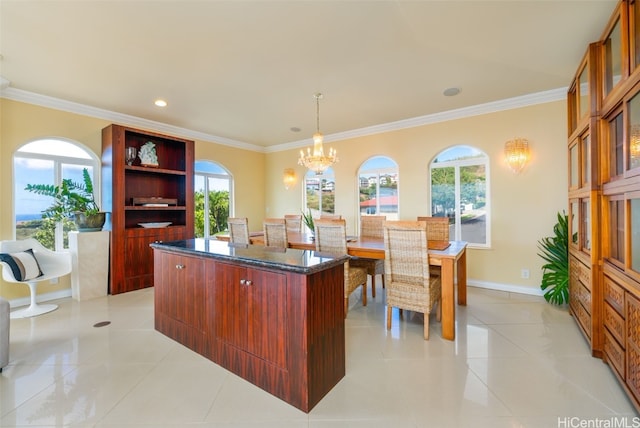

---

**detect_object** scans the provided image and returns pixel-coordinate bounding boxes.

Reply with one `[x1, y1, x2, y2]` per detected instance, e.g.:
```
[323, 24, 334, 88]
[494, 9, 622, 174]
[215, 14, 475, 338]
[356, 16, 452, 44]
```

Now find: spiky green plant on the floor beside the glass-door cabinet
[538, 211, 569, 305]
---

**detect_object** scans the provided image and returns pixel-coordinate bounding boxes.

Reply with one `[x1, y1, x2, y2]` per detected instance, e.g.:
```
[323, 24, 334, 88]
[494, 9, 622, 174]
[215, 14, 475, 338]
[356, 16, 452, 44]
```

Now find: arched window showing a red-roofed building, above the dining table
[358, 156, 398, 220]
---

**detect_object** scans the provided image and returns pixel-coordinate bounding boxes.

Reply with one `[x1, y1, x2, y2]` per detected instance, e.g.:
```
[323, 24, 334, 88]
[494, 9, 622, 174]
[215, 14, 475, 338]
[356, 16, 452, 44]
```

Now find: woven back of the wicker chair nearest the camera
[384, 221, 429, 287]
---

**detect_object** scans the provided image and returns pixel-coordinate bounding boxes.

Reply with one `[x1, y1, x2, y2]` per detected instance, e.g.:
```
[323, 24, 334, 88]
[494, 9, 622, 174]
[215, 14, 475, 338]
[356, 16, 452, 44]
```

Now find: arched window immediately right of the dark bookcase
[194, 161, 233, 238]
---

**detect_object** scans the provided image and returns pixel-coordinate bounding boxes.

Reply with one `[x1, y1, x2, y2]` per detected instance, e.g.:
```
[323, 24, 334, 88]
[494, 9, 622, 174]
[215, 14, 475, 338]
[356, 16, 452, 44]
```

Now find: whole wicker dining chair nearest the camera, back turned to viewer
[384, 221, 442, 340]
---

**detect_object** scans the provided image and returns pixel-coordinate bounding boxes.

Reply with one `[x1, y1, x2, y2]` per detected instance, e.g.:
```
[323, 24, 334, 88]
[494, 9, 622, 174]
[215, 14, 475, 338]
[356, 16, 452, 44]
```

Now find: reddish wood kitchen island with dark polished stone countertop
[151, 239, 347, 412]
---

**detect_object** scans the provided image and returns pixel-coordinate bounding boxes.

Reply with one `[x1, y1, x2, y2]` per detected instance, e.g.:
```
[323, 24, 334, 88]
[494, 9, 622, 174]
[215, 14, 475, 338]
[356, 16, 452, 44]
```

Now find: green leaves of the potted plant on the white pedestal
[25, 168, 100, 221]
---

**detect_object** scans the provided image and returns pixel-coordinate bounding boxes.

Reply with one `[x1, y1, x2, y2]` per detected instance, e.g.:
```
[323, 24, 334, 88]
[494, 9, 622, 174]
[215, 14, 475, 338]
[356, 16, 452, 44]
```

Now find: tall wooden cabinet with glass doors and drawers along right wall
[568, 0, 640, 411]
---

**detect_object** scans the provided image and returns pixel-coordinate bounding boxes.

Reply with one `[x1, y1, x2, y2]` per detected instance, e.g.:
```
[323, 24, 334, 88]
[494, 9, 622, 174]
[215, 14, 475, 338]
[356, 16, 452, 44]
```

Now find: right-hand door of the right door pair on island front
[247, 269, 289, 368]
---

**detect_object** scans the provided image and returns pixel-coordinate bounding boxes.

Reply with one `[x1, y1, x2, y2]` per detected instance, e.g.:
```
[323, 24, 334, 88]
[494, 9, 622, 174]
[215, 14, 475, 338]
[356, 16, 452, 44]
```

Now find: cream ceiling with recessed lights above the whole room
[0, 0, 617, 148]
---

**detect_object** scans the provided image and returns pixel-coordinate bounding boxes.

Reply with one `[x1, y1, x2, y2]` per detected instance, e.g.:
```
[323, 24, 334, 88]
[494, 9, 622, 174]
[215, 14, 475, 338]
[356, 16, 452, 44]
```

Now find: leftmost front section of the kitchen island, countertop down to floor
[154, 252, 207, 354]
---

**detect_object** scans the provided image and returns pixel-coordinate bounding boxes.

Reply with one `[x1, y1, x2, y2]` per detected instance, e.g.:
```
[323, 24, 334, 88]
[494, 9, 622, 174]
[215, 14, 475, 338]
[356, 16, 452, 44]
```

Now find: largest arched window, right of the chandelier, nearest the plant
[429, 146, 490, 247]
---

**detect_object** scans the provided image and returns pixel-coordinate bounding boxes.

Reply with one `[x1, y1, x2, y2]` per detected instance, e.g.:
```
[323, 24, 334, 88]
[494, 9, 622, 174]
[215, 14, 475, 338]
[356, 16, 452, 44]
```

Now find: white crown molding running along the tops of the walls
[0, 87, 567, 153]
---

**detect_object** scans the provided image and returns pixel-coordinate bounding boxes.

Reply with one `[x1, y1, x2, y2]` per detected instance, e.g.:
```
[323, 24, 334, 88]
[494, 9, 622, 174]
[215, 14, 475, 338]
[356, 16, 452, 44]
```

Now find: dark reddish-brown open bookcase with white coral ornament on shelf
[102, 125, 194, 294]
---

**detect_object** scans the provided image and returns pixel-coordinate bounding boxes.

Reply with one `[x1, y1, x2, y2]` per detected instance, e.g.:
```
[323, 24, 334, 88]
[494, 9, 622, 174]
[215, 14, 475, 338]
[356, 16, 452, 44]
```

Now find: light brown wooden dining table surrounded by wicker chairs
[216, 232, 467, 340]
